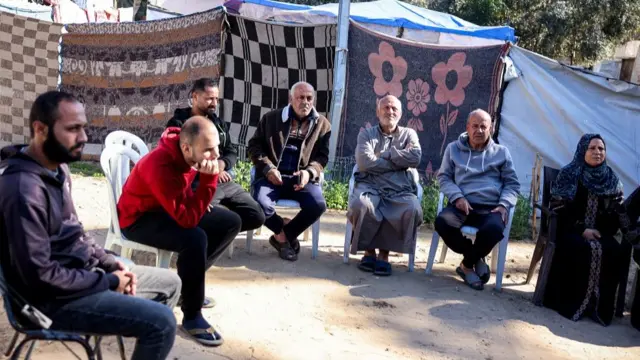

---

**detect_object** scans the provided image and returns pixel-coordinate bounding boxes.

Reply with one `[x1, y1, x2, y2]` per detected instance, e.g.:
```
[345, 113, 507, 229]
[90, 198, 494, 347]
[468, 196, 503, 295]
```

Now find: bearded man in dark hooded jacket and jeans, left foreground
[0, 91, 181, 359]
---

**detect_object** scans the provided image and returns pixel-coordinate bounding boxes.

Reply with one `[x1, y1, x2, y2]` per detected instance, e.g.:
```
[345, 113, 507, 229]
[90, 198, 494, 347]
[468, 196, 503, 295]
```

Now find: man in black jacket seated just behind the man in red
[167, 78, 264, 233]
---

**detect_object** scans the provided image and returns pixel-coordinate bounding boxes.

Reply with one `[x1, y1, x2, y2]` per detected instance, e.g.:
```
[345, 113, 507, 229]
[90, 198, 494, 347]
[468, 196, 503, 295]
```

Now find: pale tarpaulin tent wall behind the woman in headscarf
[498, 46, 640, 195]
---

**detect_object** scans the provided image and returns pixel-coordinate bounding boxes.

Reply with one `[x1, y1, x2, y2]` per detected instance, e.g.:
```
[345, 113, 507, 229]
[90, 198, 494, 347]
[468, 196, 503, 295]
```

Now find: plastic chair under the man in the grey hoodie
[425, 192, 516, 291]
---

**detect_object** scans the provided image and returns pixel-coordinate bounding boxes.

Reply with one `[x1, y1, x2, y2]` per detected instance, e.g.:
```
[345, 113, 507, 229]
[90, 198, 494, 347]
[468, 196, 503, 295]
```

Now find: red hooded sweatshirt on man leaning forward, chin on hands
[118, 127, 218, 228]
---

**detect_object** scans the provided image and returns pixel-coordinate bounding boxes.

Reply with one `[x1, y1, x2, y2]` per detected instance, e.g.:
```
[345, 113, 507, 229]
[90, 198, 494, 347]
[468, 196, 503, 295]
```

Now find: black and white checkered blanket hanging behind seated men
[221, 14, 336, 159]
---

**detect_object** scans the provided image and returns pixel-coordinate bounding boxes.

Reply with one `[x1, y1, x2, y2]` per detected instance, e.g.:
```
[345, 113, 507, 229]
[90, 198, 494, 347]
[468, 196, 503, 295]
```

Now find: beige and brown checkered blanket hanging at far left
[0, 12, 62, 146]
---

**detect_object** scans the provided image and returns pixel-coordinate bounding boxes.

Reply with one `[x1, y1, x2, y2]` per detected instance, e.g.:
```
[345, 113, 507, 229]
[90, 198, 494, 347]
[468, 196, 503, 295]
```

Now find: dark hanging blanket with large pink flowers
[338, 21, 508, 178]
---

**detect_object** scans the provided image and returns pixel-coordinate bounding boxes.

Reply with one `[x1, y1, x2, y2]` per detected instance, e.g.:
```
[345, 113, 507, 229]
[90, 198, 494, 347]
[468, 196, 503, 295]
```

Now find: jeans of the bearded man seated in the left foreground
[44, 259, 181, 360]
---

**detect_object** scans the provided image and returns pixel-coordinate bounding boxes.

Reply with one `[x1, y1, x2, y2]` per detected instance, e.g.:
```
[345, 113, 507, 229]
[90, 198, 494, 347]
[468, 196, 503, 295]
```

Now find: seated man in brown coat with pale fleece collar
[248, 82, 331, 261]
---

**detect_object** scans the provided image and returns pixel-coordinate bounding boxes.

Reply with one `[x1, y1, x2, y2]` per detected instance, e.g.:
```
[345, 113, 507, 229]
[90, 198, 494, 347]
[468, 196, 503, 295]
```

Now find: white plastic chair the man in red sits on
[100, 141, 172, 268]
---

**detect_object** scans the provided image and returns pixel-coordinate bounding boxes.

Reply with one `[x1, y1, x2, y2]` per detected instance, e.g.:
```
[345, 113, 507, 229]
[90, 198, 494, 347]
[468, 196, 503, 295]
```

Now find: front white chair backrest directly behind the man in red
[100, 144, 141, 237]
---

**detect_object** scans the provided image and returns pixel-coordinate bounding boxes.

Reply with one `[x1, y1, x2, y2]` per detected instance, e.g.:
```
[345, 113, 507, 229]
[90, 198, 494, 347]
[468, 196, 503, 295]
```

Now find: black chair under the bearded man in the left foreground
[0, 269, 126, 360]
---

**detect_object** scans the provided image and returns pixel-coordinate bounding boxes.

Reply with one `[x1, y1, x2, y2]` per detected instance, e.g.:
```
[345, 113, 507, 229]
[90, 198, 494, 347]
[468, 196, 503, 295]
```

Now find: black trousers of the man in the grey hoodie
[434, 204, 505, 268]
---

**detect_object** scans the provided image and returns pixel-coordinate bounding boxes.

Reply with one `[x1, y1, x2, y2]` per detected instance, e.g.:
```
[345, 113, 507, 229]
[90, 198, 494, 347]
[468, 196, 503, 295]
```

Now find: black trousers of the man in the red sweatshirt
[122, 210, 241, 320]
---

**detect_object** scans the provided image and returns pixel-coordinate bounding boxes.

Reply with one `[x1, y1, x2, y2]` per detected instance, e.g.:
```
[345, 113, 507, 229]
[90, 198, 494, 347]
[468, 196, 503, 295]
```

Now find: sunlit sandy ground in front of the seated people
[0, 173, 640, 360]
